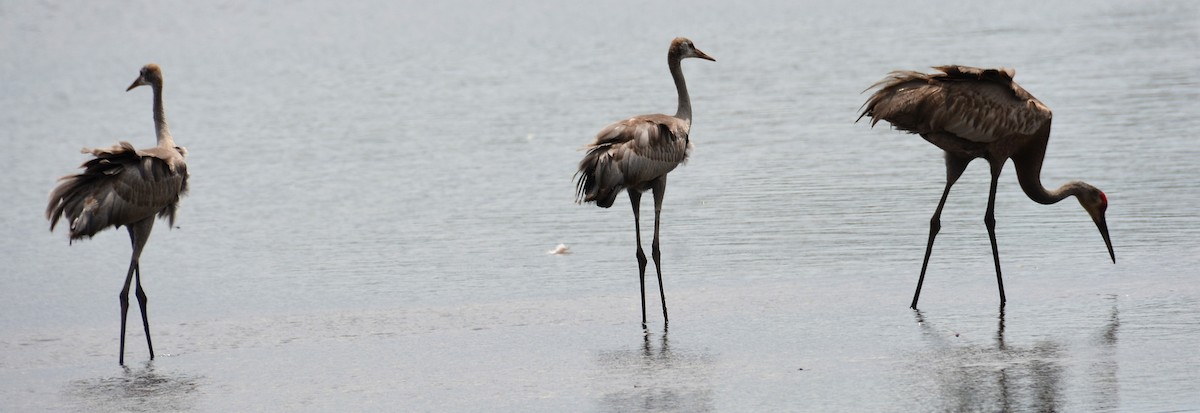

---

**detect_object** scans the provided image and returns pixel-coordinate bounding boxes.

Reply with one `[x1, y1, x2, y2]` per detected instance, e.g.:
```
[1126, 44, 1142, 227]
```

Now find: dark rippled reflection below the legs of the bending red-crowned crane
[914, 309, 1064, 412]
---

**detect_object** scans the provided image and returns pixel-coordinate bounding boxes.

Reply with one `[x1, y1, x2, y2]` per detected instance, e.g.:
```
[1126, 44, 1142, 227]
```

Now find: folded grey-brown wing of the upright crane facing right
[576, 114, 691, 207]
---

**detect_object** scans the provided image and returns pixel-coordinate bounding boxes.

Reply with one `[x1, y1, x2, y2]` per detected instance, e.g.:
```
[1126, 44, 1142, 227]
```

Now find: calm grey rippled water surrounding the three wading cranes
[0, 0, 1200, 412]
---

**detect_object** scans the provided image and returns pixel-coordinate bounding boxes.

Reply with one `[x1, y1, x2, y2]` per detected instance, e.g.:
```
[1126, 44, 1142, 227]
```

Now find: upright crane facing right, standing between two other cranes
[575, 37, 716, 328]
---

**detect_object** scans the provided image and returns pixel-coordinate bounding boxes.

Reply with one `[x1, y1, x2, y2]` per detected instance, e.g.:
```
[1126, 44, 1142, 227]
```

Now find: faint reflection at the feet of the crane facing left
[68, 361, 203, 412]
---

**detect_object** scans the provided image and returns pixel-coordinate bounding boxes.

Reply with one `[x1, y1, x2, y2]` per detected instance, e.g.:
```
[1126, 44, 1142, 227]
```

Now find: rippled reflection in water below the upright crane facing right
[599, 329, 715, 412]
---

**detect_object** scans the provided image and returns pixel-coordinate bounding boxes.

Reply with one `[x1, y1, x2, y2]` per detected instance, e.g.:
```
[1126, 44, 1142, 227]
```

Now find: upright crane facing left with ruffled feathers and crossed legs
[46, 64, 187, 365]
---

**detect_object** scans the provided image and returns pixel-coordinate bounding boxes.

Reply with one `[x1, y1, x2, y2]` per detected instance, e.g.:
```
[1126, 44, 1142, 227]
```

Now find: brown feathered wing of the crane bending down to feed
[859, 66, 1051, 143]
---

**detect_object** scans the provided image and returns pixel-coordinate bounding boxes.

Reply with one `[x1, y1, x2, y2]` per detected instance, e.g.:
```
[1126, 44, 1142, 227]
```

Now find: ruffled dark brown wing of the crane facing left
[46, 142, 187, 240]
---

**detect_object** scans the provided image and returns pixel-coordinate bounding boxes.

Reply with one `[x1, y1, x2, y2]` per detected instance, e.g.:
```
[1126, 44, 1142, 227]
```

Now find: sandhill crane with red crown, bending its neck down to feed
[858, 66, 1117, 309]
